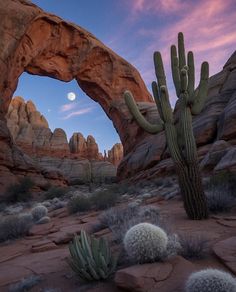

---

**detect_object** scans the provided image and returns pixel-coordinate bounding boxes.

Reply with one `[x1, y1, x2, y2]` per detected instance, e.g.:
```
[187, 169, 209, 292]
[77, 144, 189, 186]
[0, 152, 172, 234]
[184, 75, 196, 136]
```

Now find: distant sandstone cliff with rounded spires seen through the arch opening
[6, 97, 121, 188]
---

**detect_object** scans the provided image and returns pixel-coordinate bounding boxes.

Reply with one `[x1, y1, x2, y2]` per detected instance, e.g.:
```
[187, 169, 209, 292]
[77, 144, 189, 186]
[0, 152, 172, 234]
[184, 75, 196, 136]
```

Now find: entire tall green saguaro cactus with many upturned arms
[124, 32, 209, 220]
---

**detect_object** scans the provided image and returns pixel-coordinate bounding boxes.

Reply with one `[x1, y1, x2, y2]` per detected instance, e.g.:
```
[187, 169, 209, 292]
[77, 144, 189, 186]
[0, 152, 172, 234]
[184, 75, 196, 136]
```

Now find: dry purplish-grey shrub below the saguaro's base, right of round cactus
[179, 234, 208, 259]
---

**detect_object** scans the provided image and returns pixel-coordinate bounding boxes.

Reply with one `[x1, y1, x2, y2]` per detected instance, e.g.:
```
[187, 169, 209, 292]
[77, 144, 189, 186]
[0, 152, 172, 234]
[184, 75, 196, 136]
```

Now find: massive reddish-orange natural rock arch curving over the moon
[0, 0, 152, 153]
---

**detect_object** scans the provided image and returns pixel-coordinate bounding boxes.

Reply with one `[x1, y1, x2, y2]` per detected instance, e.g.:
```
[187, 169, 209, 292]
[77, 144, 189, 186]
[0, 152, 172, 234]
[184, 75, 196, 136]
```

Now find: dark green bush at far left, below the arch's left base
[5, 177, 35, 203]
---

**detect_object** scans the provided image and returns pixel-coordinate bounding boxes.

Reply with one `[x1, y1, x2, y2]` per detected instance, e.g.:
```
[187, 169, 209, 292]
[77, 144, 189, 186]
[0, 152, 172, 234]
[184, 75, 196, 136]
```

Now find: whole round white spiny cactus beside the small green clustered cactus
[124, 223, 168, 263]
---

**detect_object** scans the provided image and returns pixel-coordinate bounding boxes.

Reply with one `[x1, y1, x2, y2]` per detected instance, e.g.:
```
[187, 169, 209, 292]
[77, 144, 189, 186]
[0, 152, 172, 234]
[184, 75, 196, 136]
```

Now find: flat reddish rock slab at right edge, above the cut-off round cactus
[213, 236, 236, 275]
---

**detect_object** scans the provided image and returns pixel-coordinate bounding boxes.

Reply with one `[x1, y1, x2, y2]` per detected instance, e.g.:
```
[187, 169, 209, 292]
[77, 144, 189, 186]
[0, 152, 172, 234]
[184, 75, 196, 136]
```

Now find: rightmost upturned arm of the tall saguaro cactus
[191, 62, 209, 115]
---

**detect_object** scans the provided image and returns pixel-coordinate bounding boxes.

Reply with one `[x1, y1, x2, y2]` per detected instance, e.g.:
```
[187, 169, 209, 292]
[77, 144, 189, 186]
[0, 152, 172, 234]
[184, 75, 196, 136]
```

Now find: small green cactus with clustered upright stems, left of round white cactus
[67, 230, 117, 281]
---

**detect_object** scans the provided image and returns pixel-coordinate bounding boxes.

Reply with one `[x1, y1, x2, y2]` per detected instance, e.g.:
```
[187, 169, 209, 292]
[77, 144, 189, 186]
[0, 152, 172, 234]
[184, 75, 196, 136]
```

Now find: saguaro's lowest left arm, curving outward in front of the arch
[124, 91, 163, 134]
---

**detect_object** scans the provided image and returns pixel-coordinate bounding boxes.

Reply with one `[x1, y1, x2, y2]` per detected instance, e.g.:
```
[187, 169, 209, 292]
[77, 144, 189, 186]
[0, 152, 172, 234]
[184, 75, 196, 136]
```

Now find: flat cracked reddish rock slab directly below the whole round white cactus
[115, 256, 195, 292]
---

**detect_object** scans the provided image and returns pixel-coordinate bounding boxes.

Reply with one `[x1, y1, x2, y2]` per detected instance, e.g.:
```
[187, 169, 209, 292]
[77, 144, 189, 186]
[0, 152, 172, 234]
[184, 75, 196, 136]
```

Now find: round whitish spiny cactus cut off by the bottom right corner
[186, 269, 236, 292]
